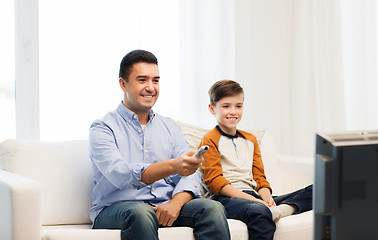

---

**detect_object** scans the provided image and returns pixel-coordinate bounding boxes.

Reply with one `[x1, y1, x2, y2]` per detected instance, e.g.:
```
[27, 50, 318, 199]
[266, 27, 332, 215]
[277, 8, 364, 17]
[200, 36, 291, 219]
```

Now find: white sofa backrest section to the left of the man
[0, 140, 93, 225]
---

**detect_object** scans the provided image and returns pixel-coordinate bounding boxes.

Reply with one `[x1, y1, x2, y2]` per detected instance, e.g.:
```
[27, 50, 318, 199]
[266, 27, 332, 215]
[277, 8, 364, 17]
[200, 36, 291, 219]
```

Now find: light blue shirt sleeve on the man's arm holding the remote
[89, 121, 150, 189]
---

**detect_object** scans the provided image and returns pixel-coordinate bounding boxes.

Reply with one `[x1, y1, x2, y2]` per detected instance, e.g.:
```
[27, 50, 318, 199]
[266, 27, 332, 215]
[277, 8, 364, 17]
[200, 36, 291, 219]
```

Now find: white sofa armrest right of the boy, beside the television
[277, 155, 314, 193]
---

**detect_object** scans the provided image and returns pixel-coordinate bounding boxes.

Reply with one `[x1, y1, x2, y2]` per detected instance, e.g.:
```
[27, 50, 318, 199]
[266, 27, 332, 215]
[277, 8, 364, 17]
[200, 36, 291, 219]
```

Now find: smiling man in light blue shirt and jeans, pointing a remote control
[89, 50, 230, 240]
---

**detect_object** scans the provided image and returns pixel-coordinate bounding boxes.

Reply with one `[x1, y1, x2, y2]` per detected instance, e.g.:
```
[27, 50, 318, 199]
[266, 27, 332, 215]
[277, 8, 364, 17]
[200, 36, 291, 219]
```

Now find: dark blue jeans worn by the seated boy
[213, 185, 312, 240]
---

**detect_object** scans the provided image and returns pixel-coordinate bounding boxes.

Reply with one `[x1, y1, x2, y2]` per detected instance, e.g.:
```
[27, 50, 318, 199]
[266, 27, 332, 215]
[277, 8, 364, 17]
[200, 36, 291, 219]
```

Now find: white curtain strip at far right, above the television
[341, 0, 378, 129]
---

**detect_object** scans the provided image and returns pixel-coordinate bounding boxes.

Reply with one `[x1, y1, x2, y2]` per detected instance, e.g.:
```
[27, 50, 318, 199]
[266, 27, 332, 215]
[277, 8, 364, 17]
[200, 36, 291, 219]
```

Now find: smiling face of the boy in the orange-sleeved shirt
[209, 93, 244, 135]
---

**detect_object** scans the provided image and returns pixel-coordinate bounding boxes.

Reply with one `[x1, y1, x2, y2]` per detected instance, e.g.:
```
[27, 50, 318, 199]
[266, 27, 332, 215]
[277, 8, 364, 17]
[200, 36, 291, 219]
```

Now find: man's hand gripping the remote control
[173, 150, 203, 177]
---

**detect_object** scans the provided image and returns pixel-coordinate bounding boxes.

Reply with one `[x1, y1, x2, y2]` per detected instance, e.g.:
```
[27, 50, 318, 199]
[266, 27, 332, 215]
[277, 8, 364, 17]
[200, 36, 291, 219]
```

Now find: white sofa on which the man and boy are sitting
[0, 123, 313, 240]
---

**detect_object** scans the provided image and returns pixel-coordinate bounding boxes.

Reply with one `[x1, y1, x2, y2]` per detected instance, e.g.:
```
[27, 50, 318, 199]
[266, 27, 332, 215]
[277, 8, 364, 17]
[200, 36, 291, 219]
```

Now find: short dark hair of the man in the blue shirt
[119, 49, 158, 81]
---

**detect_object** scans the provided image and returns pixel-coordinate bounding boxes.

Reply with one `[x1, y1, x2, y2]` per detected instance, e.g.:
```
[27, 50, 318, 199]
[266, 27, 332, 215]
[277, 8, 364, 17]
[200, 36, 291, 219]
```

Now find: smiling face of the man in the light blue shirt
[120, 62, 160, 114]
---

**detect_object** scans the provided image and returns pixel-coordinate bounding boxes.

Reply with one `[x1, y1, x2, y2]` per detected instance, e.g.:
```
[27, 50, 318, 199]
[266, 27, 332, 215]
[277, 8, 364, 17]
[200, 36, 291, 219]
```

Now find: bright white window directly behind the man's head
[39, 0, 179, 141]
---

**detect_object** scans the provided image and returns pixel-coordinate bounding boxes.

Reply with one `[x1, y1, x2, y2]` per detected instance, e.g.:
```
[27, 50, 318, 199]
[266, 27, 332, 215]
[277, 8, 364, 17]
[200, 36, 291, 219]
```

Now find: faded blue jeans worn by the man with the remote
[93, 199, 230, 240]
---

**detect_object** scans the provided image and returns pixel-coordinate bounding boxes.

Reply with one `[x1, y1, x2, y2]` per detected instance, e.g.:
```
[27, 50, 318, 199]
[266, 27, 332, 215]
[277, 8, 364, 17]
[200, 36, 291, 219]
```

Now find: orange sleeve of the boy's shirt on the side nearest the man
[200, 132, 231, 195]
